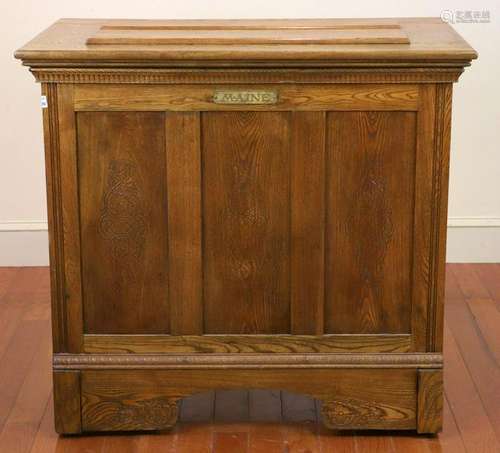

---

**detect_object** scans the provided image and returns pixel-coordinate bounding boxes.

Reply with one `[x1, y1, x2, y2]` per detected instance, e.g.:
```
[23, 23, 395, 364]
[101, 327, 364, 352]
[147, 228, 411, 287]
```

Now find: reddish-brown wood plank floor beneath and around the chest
[0, 264, 500, 453]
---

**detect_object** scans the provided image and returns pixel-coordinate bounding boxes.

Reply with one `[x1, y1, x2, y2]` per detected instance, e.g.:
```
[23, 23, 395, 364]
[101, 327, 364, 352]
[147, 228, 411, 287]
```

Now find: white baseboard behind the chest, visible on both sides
[0, 217, 500, 266]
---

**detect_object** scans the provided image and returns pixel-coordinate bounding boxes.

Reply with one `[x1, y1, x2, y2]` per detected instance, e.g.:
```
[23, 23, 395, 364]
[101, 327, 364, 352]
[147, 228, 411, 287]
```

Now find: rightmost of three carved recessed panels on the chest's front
[325, 112, 416, 334]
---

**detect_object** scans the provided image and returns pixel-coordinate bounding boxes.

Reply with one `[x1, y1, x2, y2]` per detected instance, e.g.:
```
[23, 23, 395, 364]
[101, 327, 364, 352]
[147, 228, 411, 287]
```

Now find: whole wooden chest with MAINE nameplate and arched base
[16, 19, 476, 433]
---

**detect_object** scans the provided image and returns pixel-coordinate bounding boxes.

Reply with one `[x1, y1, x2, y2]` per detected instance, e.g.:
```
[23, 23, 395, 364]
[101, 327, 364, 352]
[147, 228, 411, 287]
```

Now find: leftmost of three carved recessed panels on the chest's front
[77, 112, 169, 333]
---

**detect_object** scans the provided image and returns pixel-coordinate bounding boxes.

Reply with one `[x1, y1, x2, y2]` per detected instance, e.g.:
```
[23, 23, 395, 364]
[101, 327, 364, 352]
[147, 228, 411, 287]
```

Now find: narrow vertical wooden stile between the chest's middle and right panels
[290, 112, 325, 335]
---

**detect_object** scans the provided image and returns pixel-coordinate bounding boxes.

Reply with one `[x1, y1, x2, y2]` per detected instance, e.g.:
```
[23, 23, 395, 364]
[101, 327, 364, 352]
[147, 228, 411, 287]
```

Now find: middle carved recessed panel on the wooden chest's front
[201, 112, 290, 334]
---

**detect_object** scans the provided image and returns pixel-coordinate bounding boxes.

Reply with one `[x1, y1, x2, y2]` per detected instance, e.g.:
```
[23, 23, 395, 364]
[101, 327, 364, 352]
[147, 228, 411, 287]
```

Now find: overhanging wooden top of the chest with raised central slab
[16, 18, 477, 67]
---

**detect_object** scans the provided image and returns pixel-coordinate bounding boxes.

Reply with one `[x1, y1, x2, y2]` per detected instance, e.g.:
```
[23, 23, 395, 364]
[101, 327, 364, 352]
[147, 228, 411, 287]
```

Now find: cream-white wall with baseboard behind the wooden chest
[0, 0, 500, 265]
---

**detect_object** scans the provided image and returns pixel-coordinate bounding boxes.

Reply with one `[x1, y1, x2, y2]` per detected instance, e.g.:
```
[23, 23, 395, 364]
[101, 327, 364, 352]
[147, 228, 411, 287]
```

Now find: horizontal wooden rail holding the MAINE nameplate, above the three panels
[74, 84, 418, 111]
